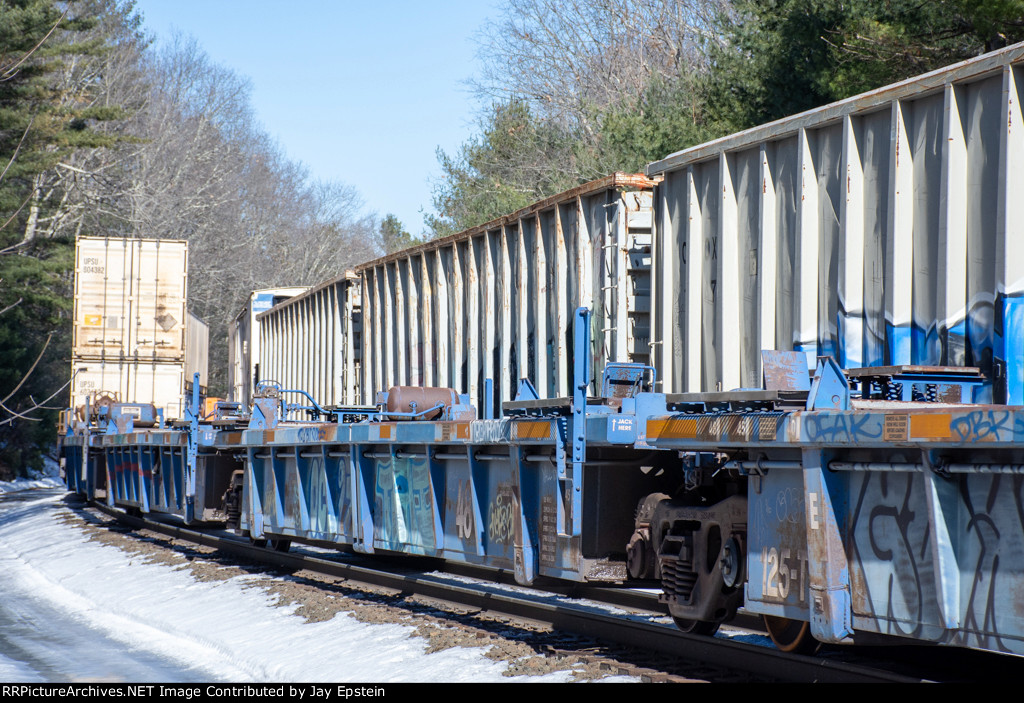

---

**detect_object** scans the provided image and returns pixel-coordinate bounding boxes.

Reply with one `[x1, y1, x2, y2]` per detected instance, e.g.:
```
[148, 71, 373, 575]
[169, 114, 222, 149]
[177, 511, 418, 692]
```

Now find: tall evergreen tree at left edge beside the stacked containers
[0, 0, 120, 478]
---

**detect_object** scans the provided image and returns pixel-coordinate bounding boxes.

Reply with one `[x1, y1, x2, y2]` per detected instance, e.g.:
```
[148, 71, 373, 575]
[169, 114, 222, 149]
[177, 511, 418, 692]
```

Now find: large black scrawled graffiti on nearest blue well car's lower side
[851, 472, 1024, 653]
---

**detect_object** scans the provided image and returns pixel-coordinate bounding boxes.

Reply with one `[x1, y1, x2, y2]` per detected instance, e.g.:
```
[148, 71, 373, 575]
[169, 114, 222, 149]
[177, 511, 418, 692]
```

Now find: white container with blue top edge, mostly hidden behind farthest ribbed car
[227, 285, 309, 404]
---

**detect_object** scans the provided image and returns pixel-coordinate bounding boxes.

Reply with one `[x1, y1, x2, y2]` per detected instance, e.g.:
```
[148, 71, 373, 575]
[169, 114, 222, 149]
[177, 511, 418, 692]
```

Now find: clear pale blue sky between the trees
[136, 0, 498, 234]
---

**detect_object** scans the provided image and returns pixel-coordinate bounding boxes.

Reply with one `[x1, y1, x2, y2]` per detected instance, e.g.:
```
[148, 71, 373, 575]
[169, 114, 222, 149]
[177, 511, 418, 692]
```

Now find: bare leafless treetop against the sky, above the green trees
[473, 0, 728, 132]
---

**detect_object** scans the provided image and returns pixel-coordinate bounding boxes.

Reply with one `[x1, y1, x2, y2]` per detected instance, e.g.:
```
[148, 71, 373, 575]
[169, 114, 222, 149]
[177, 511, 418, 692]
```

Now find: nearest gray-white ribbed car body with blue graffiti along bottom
[646, 45, 1024, 404]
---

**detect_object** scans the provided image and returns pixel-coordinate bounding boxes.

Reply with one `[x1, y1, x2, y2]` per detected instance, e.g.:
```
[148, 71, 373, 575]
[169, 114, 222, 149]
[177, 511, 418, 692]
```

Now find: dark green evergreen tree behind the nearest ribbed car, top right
[707, 0, 1024, 132]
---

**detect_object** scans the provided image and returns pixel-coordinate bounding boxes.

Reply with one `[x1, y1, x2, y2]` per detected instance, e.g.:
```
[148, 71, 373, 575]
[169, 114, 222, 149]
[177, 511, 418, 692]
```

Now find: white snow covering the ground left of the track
[0, 483, 622, 683]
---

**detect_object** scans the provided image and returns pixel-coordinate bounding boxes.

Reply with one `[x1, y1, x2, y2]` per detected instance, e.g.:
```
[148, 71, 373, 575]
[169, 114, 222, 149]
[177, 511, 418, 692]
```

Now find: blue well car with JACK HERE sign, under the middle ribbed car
[240, 310, 679, 583]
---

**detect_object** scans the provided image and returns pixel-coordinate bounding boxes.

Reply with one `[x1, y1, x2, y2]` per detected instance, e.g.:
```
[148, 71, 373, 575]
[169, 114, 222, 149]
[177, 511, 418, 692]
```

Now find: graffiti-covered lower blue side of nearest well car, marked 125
[745, 469, 1024, 654]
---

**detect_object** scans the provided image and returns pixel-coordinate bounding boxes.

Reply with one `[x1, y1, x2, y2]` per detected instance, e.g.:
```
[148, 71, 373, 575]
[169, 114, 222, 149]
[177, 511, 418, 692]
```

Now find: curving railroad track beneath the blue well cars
[66, 495, 928, 683]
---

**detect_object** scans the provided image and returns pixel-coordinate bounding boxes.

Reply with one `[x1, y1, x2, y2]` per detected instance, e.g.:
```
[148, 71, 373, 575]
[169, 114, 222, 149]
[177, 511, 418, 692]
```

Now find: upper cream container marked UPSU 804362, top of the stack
[72, 236, 188, 363]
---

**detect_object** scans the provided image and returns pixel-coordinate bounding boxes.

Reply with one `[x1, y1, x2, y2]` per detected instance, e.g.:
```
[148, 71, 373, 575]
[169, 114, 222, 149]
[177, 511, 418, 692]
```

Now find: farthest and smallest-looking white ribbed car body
[256, 271, 364, 406]
